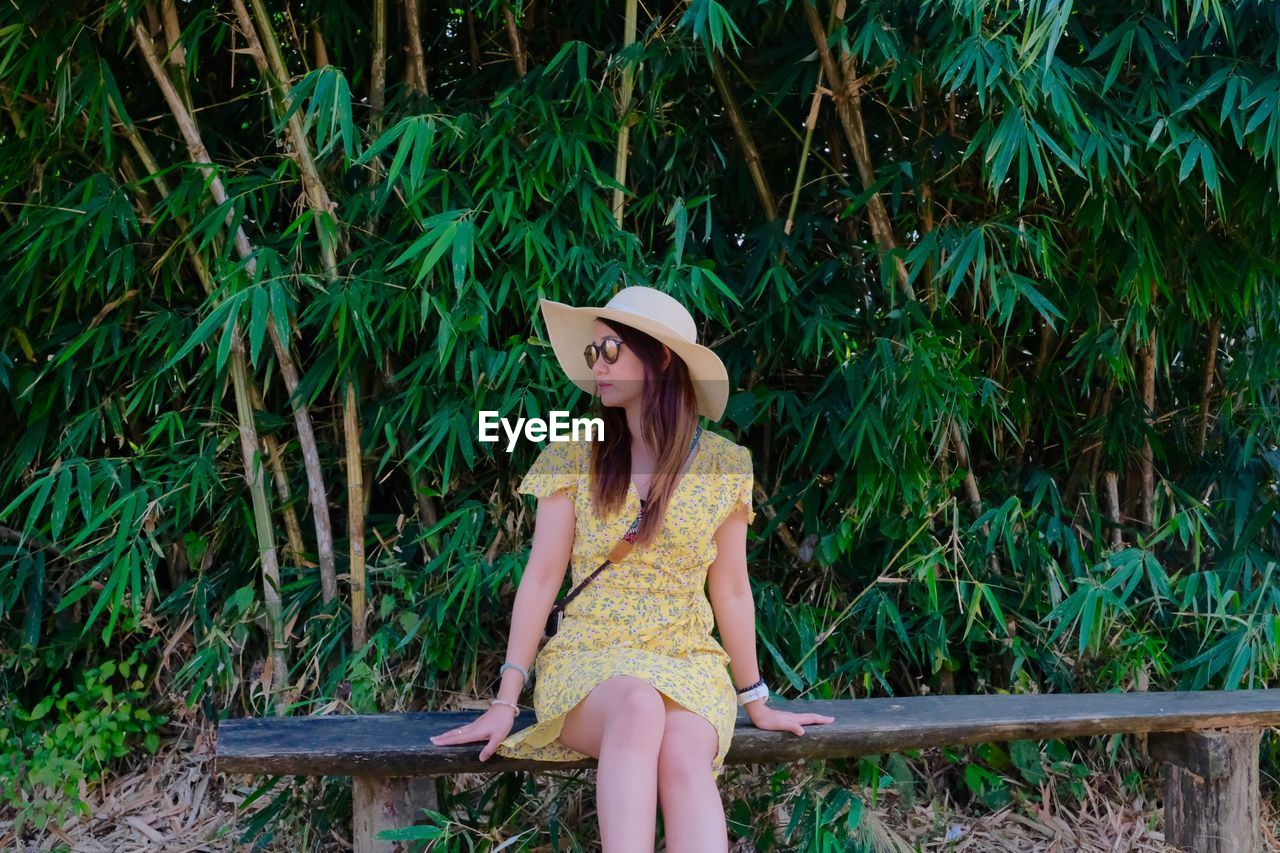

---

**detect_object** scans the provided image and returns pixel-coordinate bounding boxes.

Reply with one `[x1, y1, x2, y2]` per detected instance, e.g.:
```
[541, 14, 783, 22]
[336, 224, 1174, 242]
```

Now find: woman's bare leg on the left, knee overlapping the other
[559, 675, 667, 853]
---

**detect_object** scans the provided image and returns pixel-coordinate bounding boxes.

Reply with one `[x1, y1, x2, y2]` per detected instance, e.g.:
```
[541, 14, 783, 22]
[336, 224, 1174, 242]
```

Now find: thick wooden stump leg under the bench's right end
[1148, 729, 1262, 853]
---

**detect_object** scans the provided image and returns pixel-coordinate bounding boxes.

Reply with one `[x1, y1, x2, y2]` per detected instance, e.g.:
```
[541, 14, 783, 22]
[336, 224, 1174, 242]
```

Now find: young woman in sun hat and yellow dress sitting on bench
[431, 287, 833, 853]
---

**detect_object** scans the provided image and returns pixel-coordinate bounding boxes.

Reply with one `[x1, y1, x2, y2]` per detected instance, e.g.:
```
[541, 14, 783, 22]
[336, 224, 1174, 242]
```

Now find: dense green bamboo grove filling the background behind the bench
[0, 0, 1280, 840]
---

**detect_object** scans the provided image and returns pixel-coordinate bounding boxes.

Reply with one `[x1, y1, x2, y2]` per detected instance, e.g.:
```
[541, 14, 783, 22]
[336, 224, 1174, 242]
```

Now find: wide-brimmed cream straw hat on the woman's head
[538, 284, 728, 420]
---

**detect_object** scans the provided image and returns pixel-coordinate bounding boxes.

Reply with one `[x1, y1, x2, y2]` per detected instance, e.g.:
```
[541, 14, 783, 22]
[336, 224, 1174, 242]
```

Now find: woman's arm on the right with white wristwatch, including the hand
[707, 505, 835, 735]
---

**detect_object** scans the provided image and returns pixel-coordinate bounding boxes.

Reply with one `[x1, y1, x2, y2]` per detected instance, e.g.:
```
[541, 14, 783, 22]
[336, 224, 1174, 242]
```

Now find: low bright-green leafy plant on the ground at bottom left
[0, 647, 168, 833]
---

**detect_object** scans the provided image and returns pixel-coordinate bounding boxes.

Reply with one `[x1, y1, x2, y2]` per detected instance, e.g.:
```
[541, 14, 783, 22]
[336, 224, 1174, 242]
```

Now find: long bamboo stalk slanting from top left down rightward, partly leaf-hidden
[133, 23, 338, 603]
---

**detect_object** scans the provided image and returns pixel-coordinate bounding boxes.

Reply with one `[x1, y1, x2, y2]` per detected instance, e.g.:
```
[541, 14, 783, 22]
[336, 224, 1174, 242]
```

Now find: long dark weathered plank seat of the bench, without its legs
[216, 689, 1280, 776]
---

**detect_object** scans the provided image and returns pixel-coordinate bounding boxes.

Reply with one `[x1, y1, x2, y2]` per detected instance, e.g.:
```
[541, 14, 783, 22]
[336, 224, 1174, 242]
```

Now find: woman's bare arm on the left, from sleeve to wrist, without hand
[495, 489, 575, 701]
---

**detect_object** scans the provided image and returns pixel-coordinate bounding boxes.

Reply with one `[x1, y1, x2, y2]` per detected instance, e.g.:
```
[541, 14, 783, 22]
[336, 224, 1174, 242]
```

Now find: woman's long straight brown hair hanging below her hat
[591, 318, 704, 547]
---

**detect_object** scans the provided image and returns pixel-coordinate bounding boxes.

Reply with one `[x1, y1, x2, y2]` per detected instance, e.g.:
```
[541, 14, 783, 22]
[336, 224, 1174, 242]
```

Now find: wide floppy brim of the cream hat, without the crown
[538, 298, 728, 420]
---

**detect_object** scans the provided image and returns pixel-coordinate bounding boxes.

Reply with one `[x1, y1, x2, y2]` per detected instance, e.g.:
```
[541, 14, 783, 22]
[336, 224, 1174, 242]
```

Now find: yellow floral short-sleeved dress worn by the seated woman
[497, 429, 755, 779]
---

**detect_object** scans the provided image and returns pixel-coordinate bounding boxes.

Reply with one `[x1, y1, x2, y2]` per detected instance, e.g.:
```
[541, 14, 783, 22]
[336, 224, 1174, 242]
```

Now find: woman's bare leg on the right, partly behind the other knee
[658, 694, 728, 853]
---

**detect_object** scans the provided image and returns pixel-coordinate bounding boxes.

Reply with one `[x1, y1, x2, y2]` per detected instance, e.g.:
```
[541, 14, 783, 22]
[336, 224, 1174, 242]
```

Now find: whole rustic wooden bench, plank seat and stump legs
[216, 689, 1280, 853]
